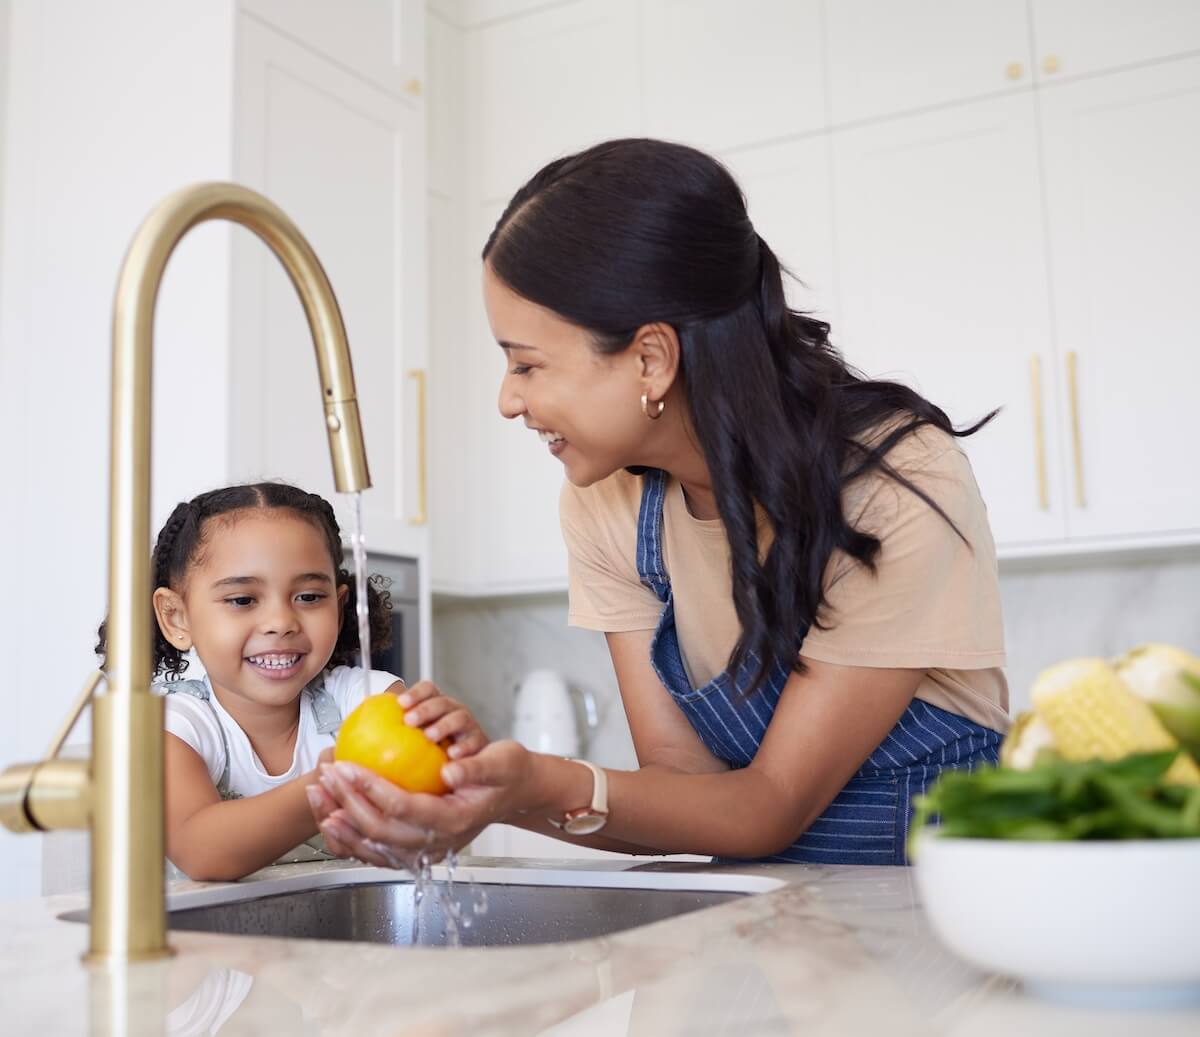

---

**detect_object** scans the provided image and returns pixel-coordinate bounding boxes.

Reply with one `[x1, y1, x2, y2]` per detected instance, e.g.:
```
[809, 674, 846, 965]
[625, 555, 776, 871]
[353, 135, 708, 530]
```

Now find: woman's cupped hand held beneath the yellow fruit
[310, 741, 534, 870]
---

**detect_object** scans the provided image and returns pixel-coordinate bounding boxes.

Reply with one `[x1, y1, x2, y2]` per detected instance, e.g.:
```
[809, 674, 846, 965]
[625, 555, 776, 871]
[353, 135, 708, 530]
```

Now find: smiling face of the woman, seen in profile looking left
[484, 263, 665, 486]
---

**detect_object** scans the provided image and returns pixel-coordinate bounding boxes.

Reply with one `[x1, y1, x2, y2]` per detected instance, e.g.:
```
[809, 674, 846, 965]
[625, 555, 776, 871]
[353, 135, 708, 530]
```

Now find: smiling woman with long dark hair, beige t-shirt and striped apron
[314, 140, 1007, 864]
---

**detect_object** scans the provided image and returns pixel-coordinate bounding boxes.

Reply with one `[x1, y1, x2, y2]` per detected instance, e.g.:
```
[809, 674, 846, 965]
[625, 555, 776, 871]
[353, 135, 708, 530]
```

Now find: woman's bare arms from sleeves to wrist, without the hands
[501, 631, 924, 857]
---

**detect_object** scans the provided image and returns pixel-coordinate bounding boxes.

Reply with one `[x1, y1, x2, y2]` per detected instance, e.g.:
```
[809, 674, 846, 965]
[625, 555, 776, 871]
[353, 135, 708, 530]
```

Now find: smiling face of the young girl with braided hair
[155, 509, 348, 706]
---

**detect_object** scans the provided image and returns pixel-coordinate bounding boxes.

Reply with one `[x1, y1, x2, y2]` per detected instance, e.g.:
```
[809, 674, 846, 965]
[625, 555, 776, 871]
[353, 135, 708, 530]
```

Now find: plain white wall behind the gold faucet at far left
[0, 0, 234, 899]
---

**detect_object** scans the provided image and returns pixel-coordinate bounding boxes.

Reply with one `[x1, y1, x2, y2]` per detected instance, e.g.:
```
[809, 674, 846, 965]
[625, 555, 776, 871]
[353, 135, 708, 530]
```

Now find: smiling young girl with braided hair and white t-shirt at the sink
[96, 482, 478, 880]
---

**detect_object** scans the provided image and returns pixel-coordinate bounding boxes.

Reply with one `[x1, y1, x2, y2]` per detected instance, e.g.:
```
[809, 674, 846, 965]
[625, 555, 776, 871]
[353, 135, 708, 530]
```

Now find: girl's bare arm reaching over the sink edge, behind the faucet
[166, 733, 317, 882]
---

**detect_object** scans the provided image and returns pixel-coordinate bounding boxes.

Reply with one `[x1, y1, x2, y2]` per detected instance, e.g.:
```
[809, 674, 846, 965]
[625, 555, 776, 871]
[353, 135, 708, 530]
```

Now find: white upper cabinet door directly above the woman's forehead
[467, 0, 642, 206]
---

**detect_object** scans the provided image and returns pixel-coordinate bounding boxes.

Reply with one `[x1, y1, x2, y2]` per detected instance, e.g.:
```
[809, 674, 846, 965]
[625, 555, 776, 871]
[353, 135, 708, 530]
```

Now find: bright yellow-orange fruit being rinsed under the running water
[334, 691, 449, 796]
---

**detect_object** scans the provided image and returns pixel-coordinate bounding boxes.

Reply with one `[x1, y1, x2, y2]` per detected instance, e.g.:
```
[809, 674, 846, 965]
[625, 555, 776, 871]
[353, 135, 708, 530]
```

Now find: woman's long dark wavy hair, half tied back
[484, 133, 995, 694]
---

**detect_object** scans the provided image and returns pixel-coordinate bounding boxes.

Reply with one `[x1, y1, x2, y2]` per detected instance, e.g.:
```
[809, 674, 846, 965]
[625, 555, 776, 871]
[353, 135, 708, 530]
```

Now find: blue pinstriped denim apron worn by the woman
[637, 469, 1001, 864]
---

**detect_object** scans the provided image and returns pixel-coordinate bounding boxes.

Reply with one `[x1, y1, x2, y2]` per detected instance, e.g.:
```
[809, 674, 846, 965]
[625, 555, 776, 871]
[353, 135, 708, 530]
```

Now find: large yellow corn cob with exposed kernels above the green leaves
[1032, 659, 1200, 785]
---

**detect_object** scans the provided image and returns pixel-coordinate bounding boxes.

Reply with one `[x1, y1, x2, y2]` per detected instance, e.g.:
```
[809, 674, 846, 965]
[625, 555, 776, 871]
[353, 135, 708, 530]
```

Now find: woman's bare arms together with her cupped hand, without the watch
[314, 631, 924, 858]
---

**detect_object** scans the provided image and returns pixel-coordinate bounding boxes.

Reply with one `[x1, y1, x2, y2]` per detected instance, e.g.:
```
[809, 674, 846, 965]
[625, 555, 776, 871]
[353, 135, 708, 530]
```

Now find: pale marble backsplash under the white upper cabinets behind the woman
[433, 551, 1200, 753]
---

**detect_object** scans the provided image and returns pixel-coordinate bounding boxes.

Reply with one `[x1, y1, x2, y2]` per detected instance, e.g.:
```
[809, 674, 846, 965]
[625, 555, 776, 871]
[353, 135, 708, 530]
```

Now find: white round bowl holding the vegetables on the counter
[916, 831, 1200, 1007]
